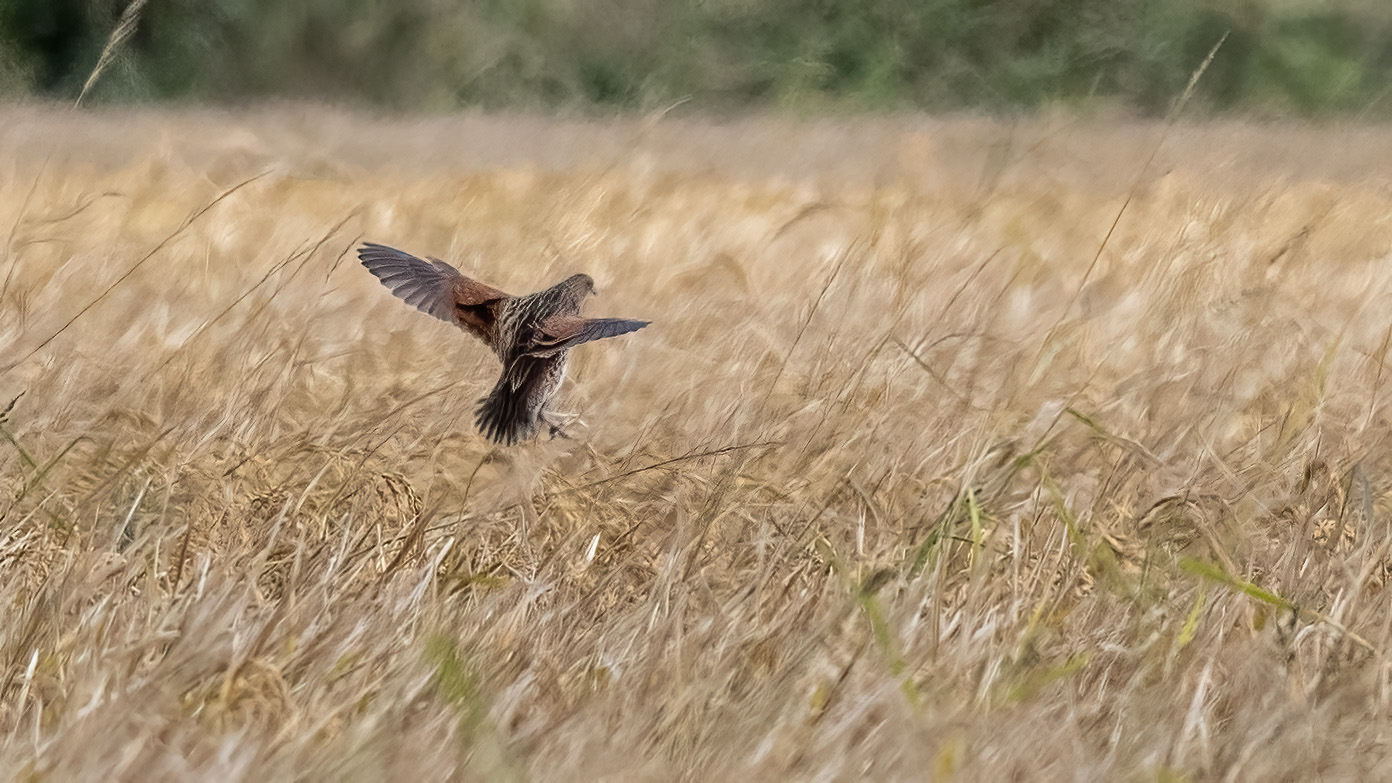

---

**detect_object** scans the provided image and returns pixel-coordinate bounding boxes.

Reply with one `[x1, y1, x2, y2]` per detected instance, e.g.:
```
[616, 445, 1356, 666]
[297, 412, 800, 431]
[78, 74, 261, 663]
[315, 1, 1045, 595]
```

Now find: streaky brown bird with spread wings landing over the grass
[358, 242, 649, 446]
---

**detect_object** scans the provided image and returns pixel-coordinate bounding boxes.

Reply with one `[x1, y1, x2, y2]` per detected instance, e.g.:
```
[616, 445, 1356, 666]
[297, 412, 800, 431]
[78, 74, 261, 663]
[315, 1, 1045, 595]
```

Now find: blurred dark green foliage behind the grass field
[0, 0, 1392, 114]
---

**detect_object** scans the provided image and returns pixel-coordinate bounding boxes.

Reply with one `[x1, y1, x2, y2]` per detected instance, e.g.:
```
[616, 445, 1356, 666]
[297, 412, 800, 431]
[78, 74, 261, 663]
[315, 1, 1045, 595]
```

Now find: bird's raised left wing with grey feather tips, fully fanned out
[358, 242, 511, 346]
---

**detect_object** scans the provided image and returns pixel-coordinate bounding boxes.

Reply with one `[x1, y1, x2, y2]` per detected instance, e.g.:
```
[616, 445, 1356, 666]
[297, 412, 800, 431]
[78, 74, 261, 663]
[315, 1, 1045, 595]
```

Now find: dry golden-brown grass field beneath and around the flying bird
[0, 106, 1392, 783]
